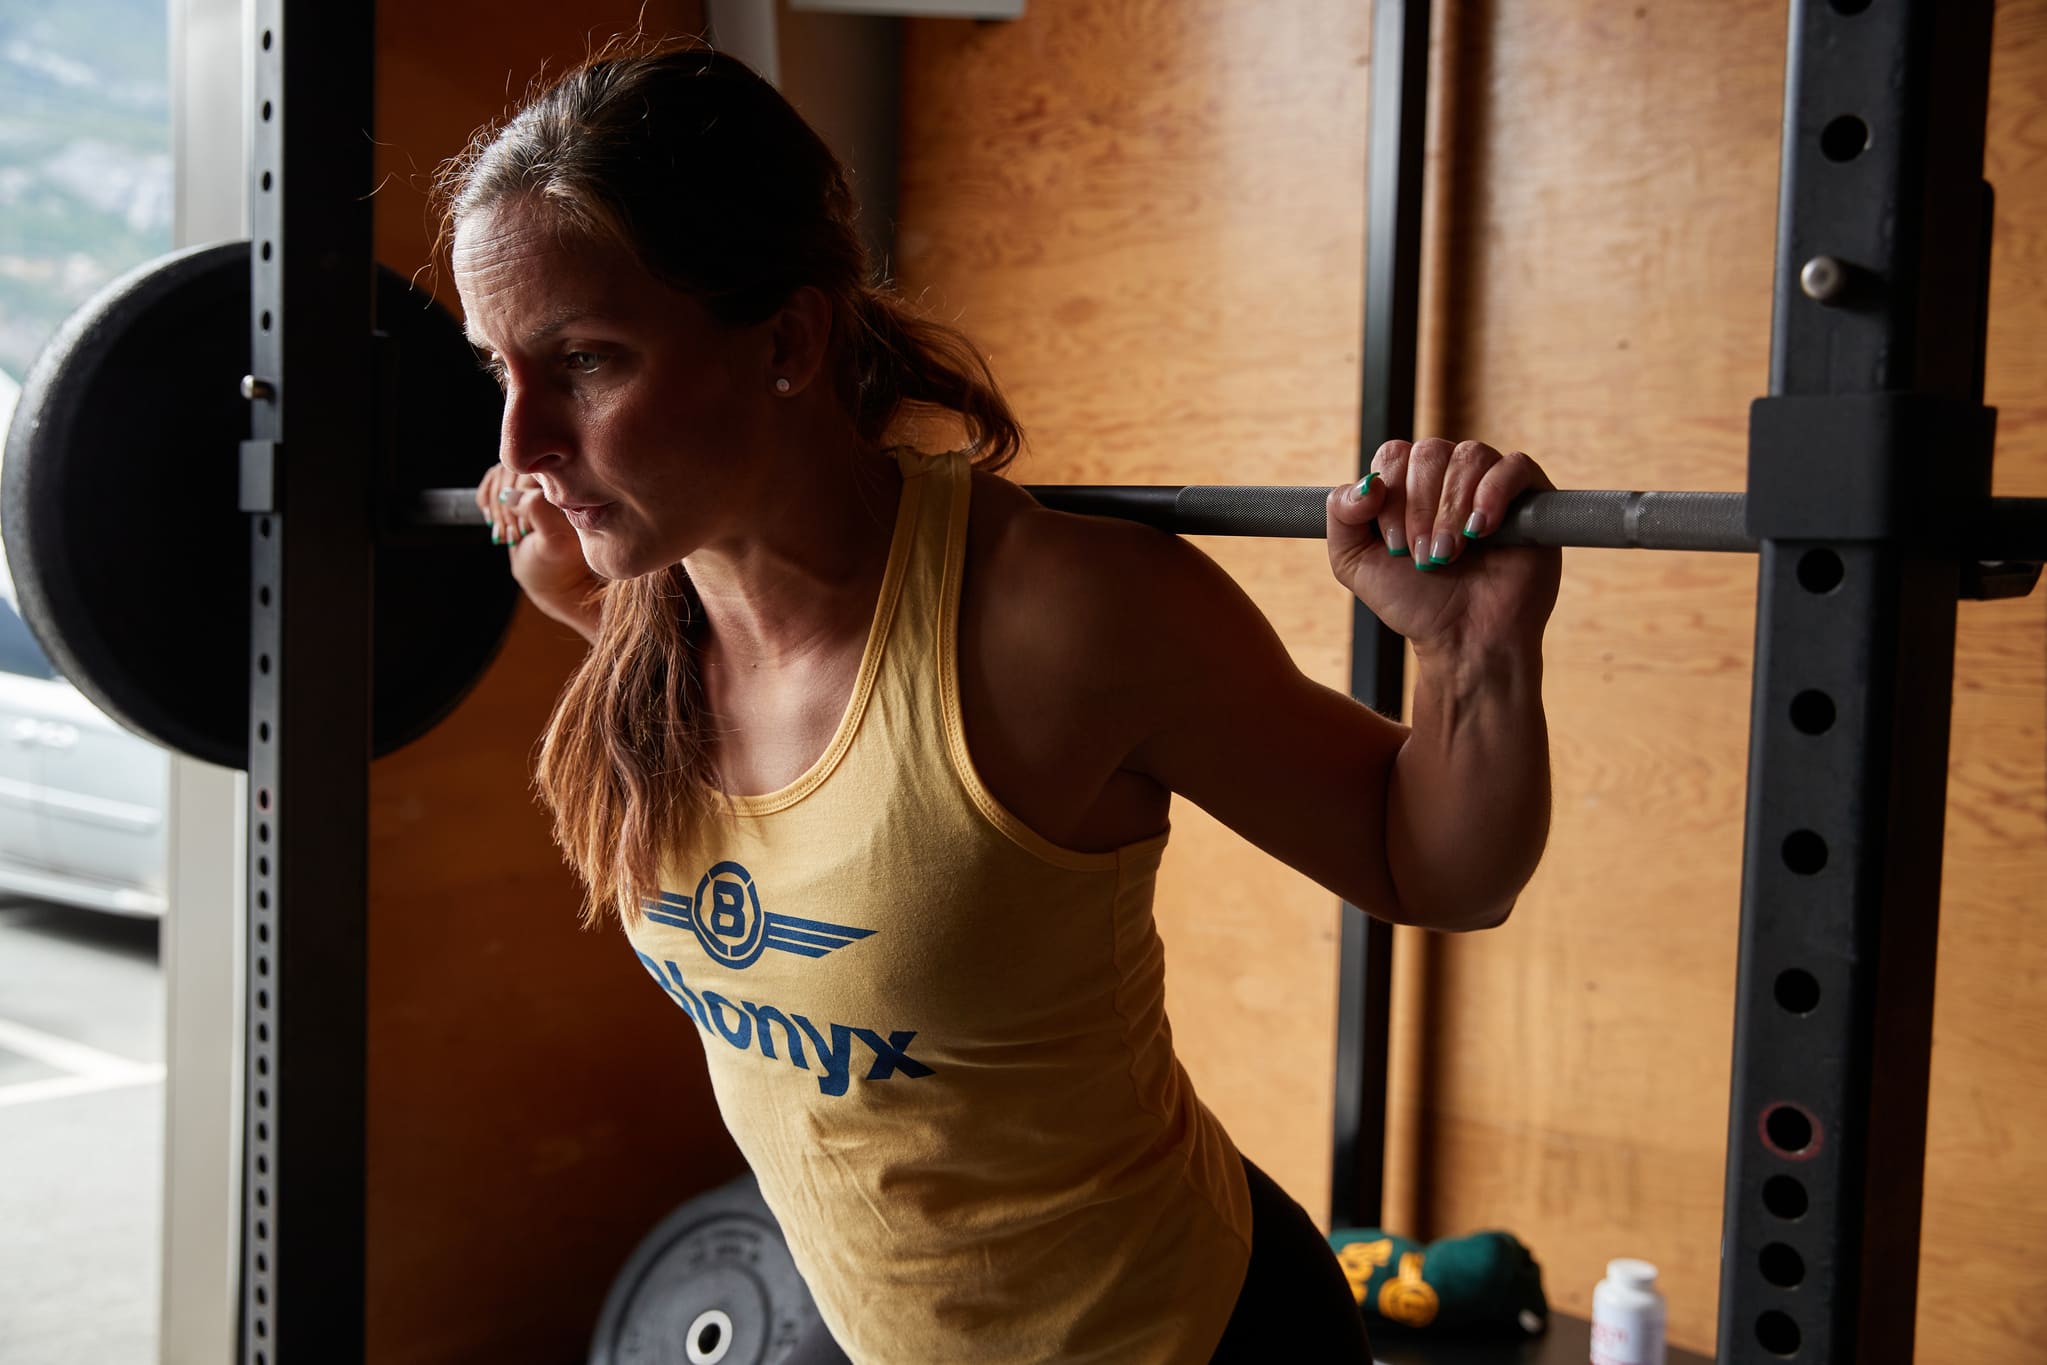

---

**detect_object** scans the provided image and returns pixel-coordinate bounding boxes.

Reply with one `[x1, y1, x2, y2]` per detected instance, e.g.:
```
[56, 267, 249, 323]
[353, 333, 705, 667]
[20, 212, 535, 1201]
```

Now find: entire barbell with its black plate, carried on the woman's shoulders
[0, 241, 2047, 767]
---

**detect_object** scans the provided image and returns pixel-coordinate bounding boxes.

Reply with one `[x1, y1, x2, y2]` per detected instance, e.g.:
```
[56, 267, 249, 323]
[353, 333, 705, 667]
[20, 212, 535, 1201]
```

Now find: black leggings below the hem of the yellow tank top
[782, 1158, 1371, 1365]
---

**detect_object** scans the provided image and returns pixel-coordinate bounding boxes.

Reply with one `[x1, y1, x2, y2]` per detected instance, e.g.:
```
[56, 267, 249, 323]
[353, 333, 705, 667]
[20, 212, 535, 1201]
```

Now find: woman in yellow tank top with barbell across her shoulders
[456, 45, 1558, 1365]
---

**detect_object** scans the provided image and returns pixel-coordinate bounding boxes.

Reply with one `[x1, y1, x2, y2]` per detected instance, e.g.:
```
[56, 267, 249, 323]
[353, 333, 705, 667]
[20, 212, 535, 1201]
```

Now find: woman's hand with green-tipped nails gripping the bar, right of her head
[1329, 440, 1564, 653]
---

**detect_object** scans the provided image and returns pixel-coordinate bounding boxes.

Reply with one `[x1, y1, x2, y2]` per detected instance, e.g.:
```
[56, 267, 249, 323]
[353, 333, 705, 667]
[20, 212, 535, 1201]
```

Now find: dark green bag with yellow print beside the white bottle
[1329, 1228, 1550, 1336]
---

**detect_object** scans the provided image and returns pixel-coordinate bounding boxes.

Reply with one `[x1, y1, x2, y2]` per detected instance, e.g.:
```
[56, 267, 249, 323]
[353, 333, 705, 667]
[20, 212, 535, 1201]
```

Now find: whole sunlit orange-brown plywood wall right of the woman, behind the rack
[899, 0, 2047, 1363]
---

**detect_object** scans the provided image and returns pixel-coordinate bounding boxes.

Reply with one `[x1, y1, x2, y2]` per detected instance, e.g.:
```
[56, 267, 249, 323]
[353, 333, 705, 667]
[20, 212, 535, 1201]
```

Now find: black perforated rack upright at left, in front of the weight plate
[239, 0, 375, 1365]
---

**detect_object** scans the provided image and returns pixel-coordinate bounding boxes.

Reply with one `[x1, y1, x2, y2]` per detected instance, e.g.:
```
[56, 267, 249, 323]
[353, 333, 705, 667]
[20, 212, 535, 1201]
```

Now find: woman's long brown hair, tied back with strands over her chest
[436, 39, 1021, 923]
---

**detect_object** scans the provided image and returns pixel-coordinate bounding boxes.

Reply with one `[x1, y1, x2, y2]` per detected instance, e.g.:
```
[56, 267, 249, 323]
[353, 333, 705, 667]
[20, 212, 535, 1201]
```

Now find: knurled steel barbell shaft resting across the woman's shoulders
[413, 483, 2047, 563]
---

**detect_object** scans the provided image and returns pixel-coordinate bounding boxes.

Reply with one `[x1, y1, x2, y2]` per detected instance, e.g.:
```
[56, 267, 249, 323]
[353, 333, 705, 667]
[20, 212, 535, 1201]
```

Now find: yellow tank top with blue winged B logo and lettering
[630, 452, 1251, 1365]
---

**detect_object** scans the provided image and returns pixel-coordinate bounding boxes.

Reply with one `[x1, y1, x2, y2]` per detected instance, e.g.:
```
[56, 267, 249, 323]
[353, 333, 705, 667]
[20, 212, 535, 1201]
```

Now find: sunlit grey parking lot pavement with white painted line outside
[0, 900, 164, 1365]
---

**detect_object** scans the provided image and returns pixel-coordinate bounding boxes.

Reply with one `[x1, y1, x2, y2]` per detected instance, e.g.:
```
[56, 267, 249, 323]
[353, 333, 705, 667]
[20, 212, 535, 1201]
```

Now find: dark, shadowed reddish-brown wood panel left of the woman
[368, 10, 741, 1363]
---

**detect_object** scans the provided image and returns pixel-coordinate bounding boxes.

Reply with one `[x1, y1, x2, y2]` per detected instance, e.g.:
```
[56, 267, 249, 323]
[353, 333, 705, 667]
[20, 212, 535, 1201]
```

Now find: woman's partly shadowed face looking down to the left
[454, 201, 774, 579]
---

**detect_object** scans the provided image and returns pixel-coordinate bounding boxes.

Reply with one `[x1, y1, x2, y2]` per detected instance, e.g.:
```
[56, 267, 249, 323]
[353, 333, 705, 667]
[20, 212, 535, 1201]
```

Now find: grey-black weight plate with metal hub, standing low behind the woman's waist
[590, 1175, 821, 1365]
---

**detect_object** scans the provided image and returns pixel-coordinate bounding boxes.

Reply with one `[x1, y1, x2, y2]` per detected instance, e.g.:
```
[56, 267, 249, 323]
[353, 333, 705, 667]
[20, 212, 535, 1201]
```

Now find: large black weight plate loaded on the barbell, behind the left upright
[0, 241, 518, 767]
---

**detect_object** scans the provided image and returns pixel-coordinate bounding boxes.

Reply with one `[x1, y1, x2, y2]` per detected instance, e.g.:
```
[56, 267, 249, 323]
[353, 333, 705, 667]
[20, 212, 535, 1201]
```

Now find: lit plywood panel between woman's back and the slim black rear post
[897, 0, 1369, 1214]
